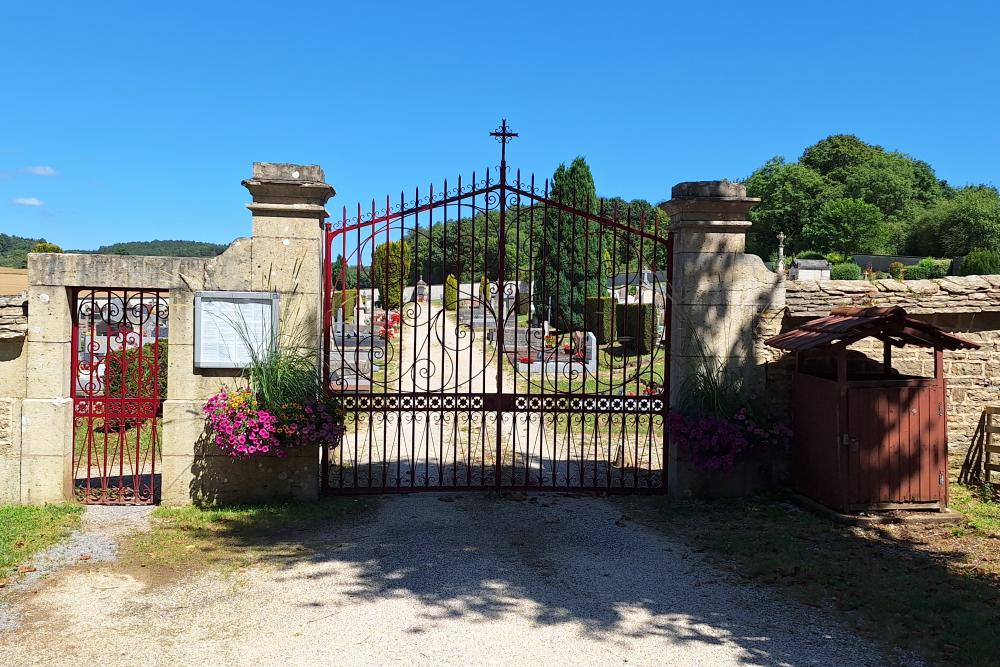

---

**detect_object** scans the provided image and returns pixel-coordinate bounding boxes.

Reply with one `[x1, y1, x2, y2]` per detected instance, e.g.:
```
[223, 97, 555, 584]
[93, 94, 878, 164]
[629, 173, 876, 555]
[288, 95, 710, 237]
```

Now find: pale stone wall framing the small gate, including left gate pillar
[0, 163, 333, 504]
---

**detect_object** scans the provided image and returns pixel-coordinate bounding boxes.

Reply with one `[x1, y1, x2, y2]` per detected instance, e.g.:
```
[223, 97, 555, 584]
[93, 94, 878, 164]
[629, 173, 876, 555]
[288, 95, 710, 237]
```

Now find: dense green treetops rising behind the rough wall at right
[746, 134, 988, 257]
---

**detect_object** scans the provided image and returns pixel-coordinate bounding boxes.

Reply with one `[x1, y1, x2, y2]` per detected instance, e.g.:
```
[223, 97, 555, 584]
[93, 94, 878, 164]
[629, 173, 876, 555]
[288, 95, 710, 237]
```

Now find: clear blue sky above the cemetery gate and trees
[0, 0, 1000, 248]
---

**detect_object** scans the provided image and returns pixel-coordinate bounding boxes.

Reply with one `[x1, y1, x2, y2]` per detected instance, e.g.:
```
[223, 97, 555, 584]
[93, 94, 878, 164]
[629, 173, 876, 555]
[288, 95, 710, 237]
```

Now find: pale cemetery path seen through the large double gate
[331, 303, 662, 488]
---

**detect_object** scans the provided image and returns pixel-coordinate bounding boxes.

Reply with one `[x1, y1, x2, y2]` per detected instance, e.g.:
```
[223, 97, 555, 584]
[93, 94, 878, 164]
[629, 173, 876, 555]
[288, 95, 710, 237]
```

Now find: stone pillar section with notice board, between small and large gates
[163, 162, 334, 504]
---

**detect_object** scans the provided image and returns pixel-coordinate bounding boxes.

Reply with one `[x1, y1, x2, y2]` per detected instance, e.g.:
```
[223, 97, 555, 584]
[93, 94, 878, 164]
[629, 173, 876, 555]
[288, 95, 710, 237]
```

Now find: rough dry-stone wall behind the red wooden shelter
[768, 276, 1000, 451]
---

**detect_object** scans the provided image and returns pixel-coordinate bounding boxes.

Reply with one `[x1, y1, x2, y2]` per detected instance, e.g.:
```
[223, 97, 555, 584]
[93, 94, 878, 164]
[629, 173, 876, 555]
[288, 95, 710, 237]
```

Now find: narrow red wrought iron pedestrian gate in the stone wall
[70, 288, 169, 505]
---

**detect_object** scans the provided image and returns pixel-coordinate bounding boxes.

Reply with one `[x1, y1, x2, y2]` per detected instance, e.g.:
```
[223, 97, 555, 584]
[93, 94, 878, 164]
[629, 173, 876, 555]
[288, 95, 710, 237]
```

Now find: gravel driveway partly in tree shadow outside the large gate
[0, 494, 885, 666]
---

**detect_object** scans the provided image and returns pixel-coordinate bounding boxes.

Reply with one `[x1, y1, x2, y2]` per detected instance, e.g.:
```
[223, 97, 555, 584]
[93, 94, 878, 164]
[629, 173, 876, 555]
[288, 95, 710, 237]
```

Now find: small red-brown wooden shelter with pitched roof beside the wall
[766, 307, 979, 512]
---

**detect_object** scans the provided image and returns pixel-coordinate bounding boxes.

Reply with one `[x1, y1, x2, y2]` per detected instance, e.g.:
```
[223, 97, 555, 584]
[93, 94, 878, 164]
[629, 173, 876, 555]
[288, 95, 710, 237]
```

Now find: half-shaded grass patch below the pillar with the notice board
[122, 498, 374, 579]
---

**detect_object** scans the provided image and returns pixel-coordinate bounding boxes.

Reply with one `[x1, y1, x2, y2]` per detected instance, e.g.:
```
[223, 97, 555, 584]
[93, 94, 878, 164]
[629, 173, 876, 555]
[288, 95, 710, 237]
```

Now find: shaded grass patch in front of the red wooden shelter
[622, 498, 1000, 665]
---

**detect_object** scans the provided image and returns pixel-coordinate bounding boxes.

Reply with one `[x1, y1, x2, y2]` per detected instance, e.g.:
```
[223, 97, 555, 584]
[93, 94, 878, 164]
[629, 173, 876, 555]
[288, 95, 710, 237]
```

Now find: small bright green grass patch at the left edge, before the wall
[0, 505, 83, 580]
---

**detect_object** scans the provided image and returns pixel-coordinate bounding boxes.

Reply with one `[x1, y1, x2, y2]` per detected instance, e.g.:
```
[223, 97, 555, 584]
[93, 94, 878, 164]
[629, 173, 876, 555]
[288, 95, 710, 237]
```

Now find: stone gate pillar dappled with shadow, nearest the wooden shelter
[662, 181, 785, 497]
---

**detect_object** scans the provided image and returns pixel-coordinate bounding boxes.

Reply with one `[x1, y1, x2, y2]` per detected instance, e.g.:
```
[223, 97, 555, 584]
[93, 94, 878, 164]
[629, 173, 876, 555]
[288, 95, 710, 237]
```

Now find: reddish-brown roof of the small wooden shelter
[765, 306, 979, 352]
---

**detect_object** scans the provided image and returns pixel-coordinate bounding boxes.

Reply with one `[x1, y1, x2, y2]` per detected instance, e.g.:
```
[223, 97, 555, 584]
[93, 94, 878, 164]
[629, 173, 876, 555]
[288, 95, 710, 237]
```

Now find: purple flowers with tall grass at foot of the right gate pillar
[667, 364, 792, 470]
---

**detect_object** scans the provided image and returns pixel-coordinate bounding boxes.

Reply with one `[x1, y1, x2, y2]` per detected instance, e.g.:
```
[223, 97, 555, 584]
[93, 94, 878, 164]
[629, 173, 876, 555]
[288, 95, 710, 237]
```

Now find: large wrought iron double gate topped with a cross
[322, 121, 671, 494]
